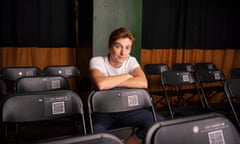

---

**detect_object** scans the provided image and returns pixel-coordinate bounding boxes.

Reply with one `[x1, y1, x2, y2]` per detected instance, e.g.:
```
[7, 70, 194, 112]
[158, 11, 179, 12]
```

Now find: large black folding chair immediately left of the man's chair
[1, 90, 86, 143]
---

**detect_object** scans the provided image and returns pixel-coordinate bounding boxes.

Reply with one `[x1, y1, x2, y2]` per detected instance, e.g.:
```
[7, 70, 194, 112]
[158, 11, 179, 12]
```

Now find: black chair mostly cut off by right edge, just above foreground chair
[224, 79, 240, 128]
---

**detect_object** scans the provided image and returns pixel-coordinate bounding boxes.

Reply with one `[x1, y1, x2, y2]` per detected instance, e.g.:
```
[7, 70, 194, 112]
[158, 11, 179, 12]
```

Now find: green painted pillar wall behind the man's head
[92, 0, 142, 62]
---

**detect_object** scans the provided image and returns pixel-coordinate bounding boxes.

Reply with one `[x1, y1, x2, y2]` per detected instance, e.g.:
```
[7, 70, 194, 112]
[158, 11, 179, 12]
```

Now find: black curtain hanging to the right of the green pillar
[142, 0, 240, 49]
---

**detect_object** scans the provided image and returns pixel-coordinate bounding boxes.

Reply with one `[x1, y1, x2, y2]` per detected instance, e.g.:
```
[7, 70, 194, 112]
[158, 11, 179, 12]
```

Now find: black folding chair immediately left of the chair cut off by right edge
[196, 69, 226, 108]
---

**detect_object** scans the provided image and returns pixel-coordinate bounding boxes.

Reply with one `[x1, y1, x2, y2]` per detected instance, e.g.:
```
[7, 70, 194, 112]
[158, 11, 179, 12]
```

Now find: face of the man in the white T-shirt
[109, 38, 132, 64]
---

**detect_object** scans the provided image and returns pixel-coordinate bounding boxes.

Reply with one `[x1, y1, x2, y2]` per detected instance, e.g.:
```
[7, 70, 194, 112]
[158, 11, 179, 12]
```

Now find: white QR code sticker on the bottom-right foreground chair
[208, 130, 225, 144]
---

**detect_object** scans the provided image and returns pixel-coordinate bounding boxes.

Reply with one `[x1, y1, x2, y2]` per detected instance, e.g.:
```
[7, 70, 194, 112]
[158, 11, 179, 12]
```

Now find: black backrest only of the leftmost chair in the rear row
[1, 66, 42, 81]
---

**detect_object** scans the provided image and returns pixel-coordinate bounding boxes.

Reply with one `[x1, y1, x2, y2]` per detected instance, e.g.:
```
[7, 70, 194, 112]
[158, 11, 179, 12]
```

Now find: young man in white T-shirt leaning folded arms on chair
[89, 27, 164, 144]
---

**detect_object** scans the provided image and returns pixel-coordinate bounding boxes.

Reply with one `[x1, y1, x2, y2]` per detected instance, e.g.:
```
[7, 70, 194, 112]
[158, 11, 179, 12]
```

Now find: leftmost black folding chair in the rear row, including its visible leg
[1, 66, 42, 94]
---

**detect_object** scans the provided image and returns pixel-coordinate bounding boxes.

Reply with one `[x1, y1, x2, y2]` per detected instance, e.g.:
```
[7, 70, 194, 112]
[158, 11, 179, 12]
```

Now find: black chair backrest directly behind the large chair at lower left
[14, 75, 70, 93]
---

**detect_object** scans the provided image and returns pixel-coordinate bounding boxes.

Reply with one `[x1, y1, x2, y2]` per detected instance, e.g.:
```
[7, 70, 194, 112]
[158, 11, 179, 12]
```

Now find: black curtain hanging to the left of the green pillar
[0, 0, 76, 47]
